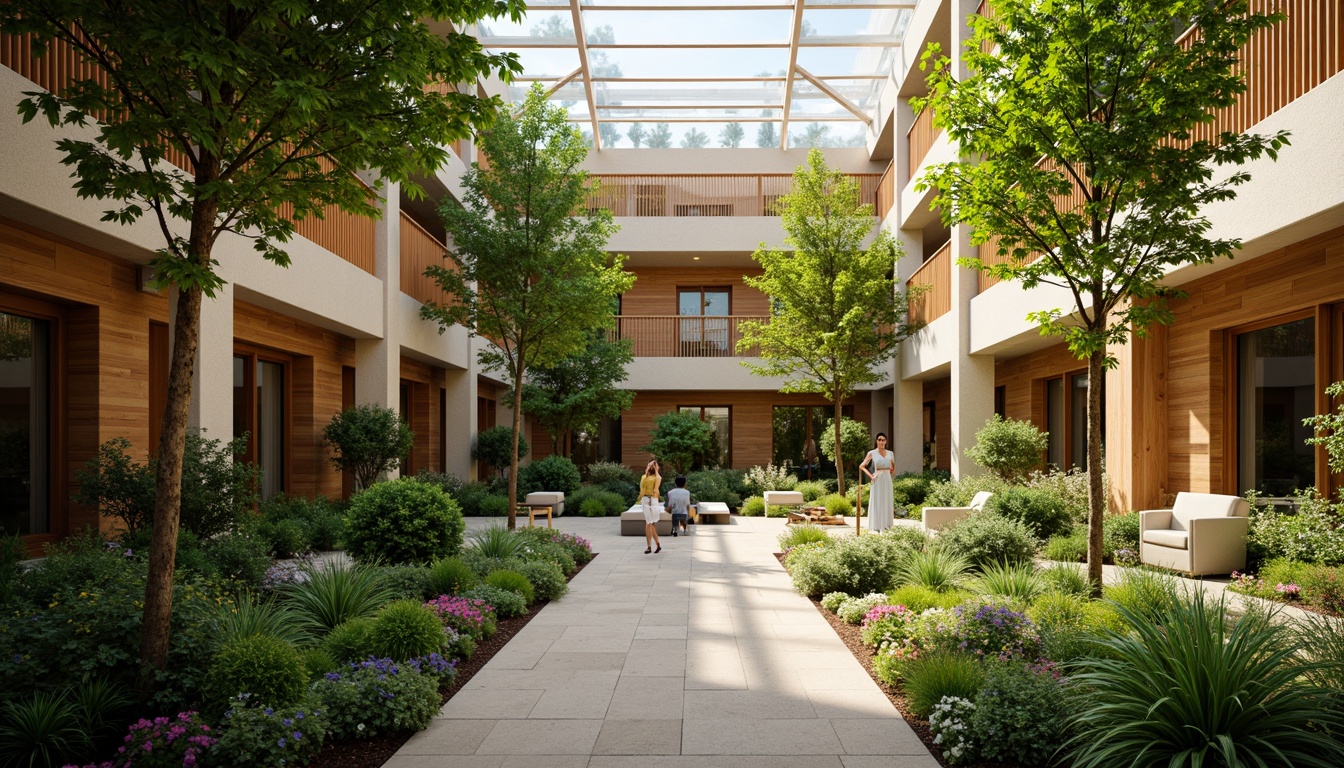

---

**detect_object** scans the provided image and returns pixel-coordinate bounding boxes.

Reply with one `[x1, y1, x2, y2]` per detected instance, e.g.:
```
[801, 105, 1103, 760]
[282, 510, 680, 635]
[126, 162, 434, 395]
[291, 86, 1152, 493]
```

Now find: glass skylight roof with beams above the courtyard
[476, 0, 914, 147]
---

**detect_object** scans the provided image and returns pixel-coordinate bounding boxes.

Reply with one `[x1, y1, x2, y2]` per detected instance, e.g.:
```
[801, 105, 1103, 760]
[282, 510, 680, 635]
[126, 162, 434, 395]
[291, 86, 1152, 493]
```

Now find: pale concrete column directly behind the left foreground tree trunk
[174, 282, 234, 443]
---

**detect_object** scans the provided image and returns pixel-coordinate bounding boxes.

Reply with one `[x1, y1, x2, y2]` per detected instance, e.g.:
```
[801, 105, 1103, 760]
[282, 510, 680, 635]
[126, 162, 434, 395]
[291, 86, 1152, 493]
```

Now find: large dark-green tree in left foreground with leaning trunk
[0, 0, 524, 691]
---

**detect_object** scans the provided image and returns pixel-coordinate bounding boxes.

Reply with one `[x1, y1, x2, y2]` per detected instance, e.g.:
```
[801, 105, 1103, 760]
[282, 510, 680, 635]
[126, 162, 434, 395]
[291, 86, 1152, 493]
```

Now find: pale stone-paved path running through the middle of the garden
[386, 516, 938, 768]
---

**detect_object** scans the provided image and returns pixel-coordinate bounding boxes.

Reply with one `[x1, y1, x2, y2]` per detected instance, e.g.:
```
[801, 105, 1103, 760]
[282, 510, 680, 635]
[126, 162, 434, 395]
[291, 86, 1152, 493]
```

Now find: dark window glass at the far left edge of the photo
[0, 311, 52, 535]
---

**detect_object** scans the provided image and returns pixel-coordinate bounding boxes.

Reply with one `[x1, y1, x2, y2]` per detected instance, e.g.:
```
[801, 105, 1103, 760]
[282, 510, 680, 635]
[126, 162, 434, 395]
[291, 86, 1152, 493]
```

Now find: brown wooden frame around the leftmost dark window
[0, 291, 70, 557]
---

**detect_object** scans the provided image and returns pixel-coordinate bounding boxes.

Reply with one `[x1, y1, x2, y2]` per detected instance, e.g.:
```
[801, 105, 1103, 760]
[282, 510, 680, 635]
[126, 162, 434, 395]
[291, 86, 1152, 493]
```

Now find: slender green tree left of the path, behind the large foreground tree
[421, 85, 634, 529]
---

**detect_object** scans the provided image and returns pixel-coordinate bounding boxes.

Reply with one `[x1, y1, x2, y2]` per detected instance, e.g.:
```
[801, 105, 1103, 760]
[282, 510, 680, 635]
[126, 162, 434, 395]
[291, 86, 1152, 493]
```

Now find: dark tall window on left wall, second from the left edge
[234, 351, 289, 499]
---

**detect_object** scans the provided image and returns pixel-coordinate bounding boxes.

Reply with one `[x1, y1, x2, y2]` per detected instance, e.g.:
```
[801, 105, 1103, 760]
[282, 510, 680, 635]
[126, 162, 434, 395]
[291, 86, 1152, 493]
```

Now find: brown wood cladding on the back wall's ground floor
[618, 391, 872, 469]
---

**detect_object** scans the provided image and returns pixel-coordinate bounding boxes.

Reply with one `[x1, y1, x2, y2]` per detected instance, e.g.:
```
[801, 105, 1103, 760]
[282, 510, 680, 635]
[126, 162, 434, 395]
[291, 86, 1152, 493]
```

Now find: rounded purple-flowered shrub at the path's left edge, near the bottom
[313, 658, 439, 738]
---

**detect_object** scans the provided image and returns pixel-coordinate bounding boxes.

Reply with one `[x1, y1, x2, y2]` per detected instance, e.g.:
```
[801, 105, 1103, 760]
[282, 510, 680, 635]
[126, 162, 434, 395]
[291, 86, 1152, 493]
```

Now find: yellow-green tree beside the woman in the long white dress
[738, 149, 911, 494]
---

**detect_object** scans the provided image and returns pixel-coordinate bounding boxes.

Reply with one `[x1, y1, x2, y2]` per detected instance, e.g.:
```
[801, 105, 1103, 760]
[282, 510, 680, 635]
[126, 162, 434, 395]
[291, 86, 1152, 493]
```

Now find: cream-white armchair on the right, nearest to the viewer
[1138, 492, 1251, 576]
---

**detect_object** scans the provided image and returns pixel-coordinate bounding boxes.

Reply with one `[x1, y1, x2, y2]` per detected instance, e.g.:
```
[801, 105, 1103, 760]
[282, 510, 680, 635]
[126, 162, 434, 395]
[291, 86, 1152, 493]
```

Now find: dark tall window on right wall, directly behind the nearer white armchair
[1236, 317, 1317, 496]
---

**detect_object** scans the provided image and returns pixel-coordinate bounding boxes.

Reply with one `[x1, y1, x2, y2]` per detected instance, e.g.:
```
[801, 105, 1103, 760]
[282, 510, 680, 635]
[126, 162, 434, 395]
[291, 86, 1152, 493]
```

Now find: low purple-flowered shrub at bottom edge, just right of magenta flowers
[215, 698, 327, 768]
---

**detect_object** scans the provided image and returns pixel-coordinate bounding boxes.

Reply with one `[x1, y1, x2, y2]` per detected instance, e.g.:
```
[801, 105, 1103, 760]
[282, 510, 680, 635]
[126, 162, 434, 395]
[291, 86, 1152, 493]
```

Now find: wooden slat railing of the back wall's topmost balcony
[587, 174, 880, 217]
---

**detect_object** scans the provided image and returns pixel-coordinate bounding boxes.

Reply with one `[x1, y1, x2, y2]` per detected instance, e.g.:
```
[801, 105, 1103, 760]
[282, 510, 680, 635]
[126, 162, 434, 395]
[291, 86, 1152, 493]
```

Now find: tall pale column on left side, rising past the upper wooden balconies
[355, 182, 402, 477]
